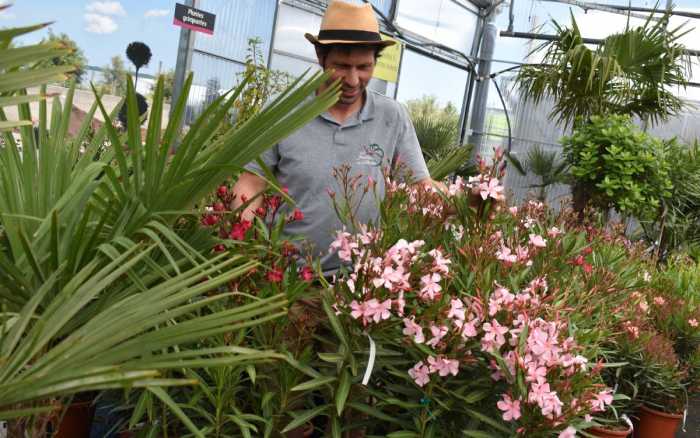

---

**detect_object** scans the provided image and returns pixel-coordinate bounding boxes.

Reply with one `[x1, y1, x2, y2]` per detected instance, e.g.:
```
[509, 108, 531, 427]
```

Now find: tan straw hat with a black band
[304, 0, 395, 47]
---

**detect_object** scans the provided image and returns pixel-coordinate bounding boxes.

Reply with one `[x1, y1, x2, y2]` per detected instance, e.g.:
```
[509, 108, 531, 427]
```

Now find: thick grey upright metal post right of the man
[469, 11, 498, 158]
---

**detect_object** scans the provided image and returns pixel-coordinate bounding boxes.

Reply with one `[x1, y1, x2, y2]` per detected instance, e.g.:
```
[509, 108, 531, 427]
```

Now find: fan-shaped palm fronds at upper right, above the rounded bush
[517, 9, 691, 125]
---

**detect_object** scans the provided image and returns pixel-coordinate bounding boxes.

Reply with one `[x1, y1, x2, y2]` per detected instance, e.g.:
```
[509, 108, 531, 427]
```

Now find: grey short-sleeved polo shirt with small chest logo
[246, 90, 430, 272]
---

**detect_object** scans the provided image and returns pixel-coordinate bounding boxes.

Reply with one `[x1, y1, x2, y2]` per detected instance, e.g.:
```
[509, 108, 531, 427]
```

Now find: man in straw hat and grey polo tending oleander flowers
[234, 1, 440, 274]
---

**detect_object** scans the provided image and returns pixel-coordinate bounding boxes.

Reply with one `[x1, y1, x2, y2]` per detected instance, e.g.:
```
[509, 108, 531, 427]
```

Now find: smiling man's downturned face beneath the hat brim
[319, 48, 375, 105]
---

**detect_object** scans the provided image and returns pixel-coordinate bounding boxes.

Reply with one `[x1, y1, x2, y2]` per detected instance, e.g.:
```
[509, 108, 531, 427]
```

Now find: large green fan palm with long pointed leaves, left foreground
[0, 17, 337, 436]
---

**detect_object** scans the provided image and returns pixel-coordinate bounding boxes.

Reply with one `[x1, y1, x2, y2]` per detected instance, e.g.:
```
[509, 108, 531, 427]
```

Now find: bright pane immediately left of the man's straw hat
[273, 4, 321, 62]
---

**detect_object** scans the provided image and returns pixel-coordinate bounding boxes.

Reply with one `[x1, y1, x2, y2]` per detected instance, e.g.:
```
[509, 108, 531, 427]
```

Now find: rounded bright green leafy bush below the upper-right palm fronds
[562, 116, 673, 219]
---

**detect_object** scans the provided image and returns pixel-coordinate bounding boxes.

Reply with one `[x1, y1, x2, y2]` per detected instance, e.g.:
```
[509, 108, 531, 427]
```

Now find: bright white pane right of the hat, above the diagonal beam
[396, 0, 478, 54]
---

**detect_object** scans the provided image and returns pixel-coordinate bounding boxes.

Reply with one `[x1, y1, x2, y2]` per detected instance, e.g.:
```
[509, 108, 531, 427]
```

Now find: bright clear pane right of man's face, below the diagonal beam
[397, 49, 468, 111]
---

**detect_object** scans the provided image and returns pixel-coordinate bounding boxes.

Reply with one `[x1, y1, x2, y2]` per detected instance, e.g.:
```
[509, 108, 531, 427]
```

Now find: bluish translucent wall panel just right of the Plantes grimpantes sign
[194, 0, 277, 63]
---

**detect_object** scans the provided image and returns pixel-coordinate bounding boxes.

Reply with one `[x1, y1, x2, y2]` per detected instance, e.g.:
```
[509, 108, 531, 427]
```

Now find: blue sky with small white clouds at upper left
[0, 0, 180, 74]
